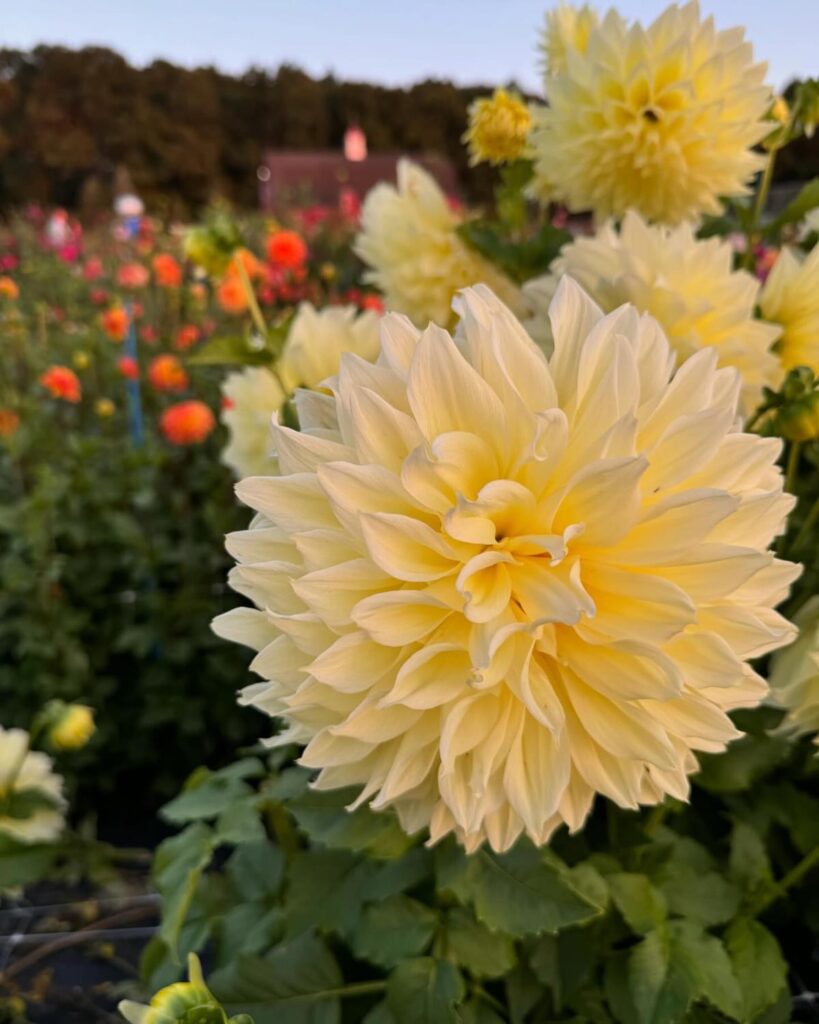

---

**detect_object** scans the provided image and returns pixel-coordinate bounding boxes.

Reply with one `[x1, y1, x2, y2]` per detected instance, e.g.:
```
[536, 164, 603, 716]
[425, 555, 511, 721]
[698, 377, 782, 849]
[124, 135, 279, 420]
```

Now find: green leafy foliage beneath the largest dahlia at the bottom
[137, 729, 819, 1024]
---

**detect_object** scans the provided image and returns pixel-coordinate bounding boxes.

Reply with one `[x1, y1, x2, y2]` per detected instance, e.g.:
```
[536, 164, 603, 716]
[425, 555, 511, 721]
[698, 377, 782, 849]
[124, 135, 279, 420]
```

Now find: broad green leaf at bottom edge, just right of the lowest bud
[208, 935, 344, 1024]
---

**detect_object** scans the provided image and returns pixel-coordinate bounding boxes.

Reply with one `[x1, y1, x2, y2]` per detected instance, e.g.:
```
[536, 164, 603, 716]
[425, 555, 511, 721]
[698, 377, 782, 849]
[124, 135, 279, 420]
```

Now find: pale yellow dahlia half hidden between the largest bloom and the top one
[523, 210, 782, 413]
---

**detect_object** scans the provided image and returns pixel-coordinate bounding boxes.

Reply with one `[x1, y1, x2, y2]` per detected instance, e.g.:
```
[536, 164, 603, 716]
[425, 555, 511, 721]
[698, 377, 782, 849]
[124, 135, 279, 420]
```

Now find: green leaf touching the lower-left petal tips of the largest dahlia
[288, 790, 416, 860]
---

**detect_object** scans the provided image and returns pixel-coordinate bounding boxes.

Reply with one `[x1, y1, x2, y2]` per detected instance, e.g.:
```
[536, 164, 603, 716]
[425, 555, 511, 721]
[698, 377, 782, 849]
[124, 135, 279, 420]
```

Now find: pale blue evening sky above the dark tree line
[0, 0, 819, 91]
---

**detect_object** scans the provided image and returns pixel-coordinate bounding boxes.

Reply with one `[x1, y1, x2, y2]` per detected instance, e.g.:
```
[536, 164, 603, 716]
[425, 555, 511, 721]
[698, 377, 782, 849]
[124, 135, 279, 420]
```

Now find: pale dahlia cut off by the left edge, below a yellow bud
[0, 726, 66, 843]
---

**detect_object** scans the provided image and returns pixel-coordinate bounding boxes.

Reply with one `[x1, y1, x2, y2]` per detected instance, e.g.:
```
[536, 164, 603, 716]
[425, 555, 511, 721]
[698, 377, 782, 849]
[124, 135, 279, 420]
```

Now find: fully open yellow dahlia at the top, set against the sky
[532, 3, 771, 223]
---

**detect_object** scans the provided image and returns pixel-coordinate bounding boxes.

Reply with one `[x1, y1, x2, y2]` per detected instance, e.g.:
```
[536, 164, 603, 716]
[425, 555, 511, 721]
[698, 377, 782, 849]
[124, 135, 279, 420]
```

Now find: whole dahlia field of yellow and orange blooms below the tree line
[0, 3, 819, 1024]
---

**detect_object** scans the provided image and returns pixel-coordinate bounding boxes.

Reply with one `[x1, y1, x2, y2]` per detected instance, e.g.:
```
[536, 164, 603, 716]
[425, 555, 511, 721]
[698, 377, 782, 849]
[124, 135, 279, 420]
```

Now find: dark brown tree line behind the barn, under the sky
[0, 46, 505, 214]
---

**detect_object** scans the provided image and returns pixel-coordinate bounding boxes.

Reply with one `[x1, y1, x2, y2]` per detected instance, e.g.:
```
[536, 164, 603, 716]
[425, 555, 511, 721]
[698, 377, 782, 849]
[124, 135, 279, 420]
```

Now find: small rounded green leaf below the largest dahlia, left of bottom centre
[352, 895, 438, 968]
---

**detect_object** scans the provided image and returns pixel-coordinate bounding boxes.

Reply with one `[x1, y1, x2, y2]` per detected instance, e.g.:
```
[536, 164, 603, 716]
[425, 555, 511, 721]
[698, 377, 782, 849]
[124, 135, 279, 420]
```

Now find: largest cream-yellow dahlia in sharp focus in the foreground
[216, 279, 798, 850]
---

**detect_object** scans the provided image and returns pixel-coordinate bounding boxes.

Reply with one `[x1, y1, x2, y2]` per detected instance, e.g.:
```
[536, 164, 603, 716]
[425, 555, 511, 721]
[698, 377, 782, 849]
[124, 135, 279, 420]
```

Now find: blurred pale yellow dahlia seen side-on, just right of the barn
[354, 160, 519, 327]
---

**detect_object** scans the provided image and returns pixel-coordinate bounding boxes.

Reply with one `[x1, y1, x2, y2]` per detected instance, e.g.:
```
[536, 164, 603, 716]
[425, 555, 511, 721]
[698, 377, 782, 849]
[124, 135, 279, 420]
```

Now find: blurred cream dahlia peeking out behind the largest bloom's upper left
[222, 302, 379, 477]
